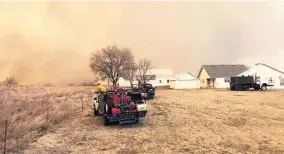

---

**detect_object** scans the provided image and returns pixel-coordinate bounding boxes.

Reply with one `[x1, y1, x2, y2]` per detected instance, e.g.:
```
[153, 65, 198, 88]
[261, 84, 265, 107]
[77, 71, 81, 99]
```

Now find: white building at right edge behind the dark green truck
[238, 63, 284, 89]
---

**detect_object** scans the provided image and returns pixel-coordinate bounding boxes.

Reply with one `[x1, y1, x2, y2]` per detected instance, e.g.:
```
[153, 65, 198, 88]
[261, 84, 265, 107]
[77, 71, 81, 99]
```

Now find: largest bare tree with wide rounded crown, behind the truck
[89, 45, 134, 87]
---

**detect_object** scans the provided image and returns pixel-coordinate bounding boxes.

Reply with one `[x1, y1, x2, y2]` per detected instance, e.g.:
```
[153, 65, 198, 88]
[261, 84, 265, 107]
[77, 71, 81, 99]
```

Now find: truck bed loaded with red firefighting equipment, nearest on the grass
[93, 89, 147, 125]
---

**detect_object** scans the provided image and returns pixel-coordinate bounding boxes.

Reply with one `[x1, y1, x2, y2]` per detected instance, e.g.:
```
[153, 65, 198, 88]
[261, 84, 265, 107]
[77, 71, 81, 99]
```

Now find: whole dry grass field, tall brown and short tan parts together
[0, 87, 284, 154]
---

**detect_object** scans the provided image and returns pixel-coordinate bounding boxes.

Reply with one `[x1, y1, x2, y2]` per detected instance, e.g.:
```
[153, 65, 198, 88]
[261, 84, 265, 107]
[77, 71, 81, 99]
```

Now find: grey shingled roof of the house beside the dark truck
[198, 65, 250, 78]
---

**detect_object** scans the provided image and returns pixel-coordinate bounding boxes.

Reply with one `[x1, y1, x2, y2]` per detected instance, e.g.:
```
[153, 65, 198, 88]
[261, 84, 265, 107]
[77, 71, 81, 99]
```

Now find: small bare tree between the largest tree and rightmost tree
[122, 63, 138, 88]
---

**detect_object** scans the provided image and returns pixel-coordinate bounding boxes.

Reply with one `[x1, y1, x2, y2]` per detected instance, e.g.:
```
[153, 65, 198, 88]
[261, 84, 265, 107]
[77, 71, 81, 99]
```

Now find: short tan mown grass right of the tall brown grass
[24, 90, 284, 154]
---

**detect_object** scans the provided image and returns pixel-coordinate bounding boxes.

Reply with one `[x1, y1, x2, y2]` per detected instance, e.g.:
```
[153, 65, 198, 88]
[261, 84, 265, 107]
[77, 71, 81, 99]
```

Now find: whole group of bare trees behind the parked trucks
[89, 45, 154, 88]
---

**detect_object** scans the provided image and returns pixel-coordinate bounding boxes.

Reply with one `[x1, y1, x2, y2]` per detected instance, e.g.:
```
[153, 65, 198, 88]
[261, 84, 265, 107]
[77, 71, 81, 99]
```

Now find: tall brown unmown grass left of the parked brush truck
[0, 86, 95, 153]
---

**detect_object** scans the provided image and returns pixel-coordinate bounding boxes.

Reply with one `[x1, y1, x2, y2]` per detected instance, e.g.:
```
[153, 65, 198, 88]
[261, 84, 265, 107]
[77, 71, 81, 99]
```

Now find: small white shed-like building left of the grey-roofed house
[170, 73, 200, 89]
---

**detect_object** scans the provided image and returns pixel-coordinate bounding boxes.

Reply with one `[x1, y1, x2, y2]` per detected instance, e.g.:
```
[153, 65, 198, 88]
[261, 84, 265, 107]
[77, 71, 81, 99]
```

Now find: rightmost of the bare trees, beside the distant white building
[138, 58, 155, 83]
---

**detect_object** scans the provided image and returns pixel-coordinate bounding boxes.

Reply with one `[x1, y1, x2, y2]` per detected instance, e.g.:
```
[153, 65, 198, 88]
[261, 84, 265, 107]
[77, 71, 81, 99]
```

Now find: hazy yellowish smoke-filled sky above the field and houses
[0, 1, 284, 84]
